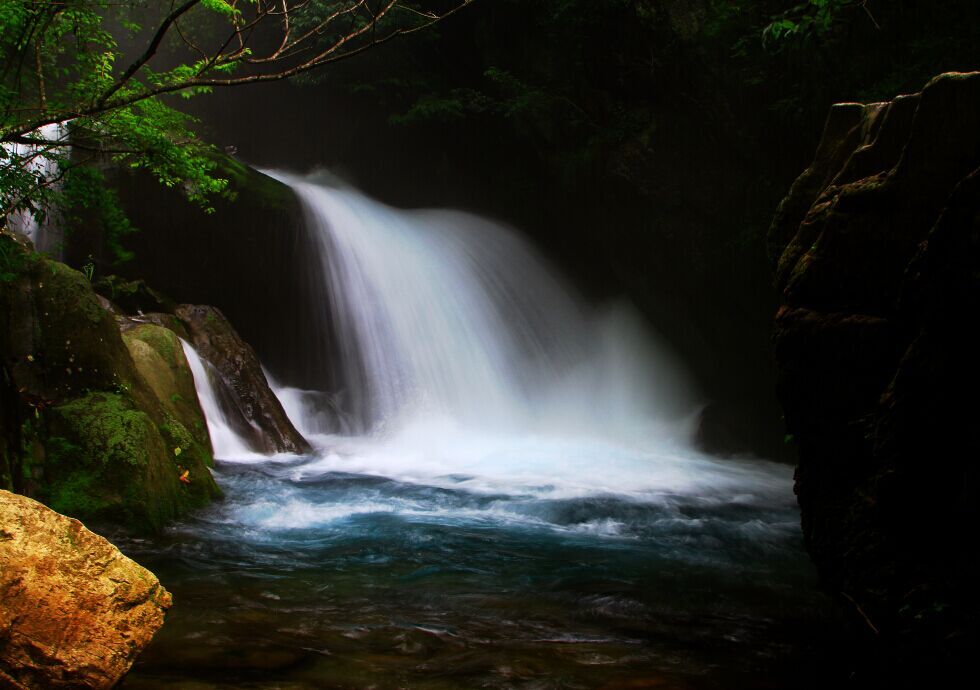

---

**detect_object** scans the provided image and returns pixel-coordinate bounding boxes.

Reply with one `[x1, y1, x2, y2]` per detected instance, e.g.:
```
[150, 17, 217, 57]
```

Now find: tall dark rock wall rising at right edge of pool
[769, 73, 980, 672]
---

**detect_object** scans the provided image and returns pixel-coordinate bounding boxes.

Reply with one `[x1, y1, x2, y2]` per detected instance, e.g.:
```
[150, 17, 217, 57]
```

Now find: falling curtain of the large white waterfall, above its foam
[272, 173, 694, 438]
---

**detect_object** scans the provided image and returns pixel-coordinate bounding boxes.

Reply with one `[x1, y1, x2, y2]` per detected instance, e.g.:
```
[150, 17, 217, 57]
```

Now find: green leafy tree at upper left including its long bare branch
[0, 0, 472, 254]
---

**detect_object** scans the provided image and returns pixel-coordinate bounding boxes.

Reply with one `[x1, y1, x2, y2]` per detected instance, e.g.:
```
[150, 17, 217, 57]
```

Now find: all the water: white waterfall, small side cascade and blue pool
[125, 173, 825, 690]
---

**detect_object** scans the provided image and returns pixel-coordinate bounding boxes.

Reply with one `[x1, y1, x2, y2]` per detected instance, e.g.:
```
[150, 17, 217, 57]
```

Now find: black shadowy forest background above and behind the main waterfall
[176, 0, 980, 458]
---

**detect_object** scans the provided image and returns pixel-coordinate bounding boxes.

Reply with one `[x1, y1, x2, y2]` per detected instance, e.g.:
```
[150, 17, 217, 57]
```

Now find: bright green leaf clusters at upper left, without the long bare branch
[0, 0, 226, 234]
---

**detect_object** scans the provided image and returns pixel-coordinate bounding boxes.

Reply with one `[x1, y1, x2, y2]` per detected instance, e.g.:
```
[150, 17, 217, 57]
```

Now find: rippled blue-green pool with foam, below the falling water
[117, 438, 848, 689]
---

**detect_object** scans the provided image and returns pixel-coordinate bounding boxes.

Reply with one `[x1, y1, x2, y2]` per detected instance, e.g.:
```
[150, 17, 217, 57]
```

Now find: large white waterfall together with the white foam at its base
[226, 173, 791, 512]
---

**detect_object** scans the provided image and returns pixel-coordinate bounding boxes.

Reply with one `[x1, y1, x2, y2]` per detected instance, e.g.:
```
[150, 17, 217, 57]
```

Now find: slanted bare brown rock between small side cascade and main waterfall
[174, 304, 311, 453]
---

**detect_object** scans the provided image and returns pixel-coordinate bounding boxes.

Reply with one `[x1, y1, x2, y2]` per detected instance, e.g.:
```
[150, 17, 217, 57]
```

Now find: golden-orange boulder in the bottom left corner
[0, 491, 171, 690]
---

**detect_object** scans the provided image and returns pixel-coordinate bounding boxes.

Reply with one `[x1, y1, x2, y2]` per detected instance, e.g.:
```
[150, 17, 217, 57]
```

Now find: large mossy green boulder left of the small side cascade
[0, 235, 219, 531]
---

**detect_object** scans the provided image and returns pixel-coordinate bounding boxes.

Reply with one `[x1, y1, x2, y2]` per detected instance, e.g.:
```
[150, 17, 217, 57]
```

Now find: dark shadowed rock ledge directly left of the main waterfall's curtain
[65, 155, 318, 389]
